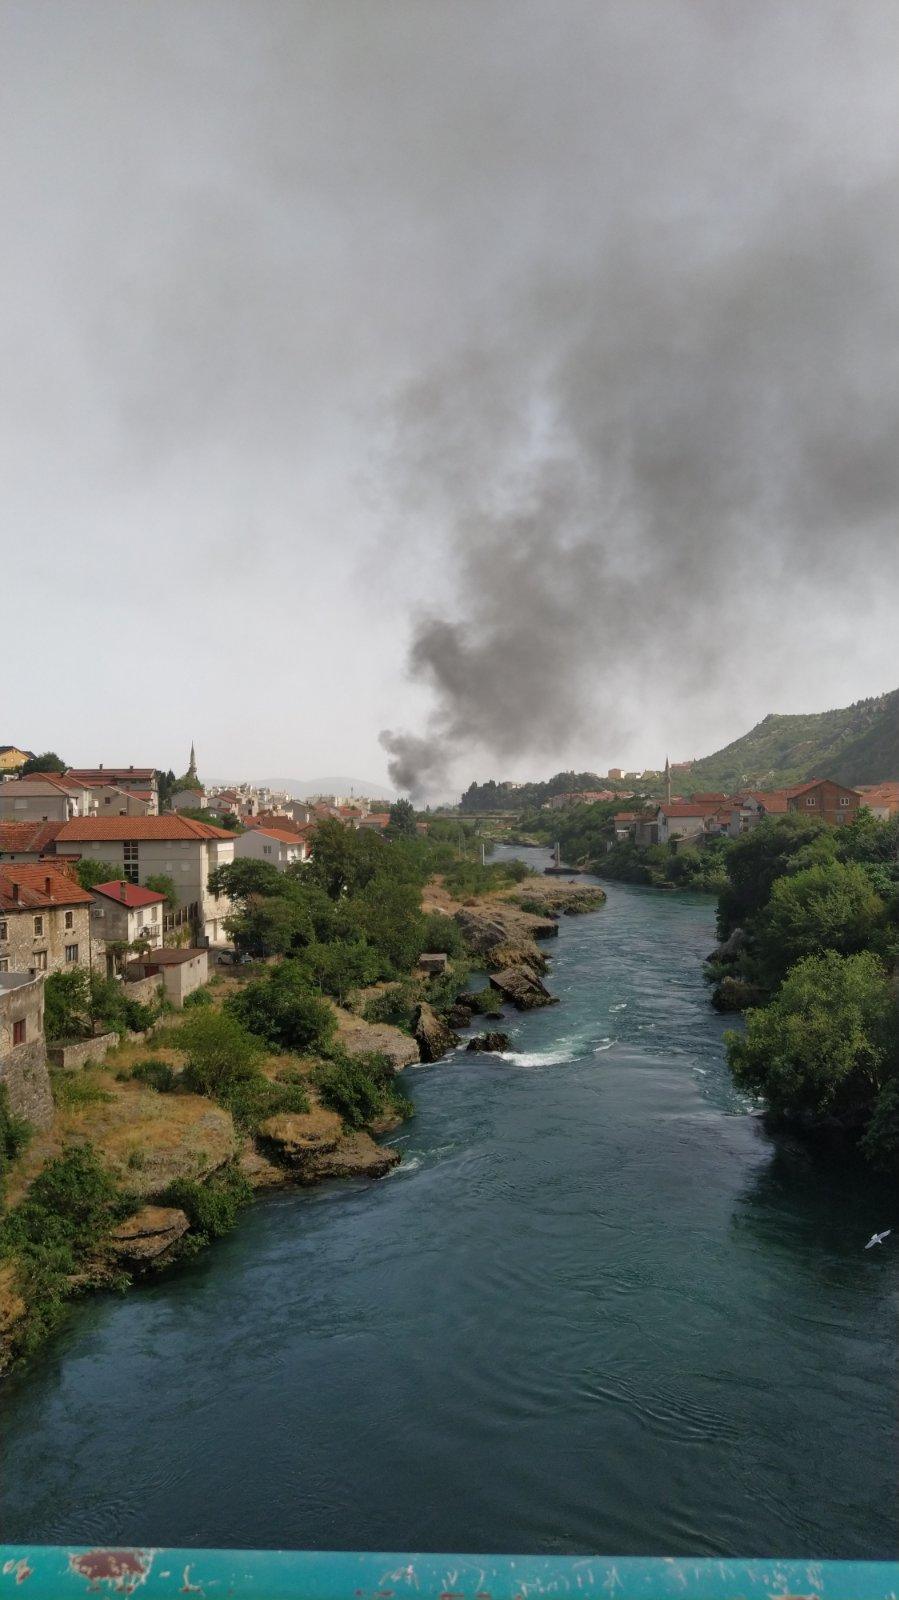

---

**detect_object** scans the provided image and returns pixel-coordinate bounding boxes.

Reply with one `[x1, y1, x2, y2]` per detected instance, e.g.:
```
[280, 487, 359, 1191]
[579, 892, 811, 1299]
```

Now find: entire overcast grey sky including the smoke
[0, 0, 899, 794]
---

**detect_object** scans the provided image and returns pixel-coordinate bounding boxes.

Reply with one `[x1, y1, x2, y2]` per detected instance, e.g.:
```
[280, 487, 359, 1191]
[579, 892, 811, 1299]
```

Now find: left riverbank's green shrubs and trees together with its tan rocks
[0, 803, 601, 1365]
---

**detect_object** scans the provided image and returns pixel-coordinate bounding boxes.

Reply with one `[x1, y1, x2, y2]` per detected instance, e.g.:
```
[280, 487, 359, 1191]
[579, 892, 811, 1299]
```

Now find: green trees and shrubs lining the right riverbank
[470, 787, 899, 1176]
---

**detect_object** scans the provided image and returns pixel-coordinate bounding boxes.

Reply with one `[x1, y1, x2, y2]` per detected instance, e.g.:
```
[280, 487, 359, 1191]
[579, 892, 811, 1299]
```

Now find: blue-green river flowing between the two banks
[2, 853, 899, 1557]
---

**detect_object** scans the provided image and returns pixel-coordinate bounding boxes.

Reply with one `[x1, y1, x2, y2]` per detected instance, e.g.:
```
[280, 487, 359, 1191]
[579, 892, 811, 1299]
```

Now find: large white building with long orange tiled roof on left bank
[56, 814, 237, 944]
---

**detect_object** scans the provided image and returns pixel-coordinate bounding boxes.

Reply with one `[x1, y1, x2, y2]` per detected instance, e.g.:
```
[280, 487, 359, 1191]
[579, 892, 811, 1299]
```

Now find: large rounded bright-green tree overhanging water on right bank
[725, 950, 897, 1128]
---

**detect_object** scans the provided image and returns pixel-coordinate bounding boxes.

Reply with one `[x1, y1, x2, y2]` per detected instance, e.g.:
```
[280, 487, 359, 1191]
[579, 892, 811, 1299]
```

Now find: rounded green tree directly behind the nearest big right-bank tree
[757, 859, 886, 984]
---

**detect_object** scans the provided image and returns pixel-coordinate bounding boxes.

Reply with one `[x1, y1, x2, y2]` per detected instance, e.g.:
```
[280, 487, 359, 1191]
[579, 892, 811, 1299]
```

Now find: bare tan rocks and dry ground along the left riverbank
[0, 878, 605, 1371]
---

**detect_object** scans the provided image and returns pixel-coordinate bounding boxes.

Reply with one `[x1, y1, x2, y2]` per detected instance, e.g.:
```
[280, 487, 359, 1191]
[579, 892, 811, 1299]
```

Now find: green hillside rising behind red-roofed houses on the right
[681, 690, 899, 792]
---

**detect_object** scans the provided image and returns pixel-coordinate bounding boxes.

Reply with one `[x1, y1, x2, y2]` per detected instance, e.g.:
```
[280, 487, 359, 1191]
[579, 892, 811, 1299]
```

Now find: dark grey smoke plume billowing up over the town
[382, 6, 899, 794]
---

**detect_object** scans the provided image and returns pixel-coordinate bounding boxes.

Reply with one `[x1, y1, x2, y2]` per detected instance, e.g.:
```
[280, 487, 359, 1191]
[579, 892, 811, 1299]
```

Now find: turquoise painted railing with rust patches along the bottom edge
[0, 1546, 899, 1600]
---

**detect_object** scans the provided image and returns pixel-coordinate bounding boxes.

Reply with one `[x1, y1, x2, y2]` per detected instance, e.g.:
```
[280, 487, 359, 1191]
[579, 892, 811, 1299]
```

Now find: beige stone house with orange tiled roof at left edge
[0, 862, 91, 974]
